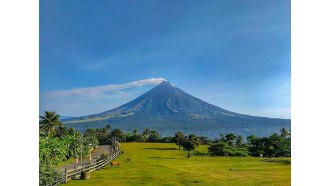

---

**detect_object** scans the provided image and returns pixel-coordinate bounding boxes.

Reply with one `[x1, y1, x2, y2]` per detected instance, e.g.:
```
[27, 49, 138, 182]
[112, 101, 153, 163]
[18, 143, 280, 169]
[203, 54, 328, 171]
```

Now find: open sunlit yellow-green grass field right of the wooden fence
[65, 143, 291, 186]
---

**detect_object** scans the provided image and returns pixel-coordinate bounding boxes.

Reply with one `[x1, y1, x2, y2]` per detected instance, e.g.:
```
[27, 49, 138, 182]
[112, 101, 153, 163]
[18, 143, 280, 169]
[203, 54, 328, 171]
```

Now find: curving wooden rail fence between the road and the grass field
[47, 149, 120, 186]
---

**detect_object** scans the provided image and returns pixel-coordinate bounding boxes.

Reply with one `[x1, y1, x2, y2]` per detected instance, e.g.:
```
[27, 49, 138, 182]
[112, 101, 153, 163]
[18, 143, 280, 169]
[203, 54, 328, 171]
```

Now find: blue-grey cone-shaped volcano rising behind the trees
[62, 81, 291, 137]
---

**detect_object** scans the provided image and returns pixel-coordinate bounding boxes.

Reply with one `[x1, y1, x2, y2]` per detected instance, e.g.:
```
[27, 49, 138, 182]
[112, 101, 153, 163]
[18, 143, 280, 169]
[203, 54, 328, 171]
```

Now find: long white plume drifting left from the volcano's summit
[46, 78, 166, 97]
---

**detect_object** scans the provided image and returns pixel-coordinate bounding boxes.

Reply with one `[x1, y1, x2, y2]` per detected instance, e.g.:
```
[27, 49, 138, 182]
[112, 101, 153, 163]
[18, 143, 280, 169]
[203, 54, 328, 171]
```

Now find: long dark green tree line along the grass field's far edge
[96, 128, 291, 157]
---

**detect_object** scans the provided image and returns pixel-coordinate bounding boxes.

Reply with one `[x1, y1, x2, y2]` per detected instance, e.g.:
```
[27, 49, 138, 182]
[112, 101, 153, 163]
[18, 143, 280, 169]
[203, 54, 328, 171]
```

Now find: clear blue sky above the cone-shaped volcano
[39, 0, 291, 118]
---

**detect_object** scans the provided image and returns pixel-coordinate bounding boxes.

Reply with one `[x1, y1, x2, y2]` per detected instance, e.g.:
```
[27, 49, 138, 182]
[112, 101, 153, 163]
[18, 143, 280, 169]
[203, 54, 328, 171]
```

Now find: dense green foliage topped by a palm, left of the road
[39, 112, 98, 185]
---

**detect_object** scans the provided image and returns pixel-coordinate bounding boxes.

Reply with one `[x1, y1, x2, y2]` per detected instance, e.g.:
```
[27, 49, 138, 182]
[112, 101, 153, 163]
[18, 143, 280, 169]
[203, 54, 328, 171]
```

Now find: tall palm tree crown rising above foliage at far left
[39, 111, 62, 136]
